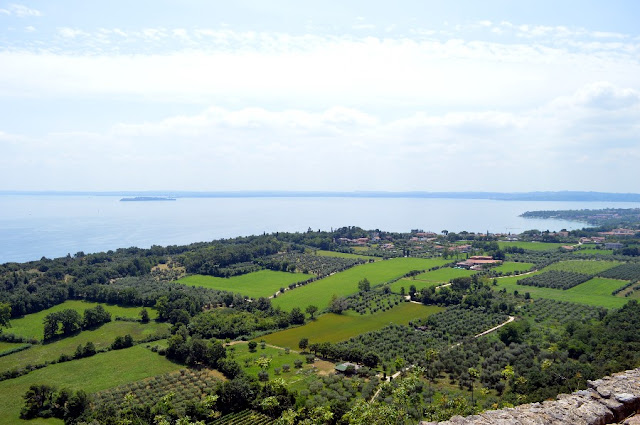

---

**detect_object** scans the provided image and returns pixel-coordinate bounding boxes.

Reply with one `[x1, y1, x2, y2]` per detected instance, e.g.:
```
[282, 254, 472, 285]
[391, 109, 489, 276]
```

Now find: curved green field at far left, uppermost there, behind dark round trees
[4, 300, 158, 340]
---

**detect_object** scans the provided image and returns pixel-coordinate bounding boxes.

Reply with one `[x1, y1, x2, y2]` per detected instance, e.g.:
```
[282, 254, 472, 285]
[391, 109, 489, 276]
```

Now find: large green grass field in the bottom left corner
[0, 345, 182, 425]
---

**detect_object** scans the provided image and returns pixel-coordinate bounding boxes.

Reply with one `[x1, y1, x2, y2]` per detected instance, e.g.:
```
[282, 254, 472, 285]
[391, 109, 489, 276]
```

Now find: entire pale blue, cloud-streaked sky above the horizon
[0, 0, 640, 192]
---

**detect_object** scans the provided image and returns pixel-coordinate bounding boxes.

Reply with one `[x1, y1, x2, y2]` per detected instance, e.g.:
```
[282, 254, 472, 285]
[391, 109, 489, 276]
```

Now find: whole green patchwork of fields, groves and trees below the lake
[0, 224, 640, 424]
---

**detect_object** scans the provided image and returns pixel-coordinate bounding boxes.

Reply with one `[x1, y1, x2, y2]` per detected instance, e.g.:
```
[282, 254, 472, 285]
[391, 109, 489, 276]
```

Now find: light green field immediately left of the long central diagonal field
[178, 270, 313, 298]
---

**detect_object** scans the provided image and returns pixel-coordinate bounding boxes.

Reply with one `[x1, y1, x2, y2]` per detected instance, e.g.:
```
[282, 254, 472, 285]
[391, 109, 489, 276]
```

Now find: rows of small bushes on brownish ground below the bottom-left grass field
[93, 369, 219, 413]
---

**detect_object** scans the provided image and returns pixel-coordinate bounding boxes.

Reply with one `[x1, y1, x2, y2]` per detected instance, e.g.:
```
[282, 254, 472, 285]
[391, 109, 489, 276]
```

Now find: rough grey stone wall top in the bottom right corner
[421, 368, 640, 425]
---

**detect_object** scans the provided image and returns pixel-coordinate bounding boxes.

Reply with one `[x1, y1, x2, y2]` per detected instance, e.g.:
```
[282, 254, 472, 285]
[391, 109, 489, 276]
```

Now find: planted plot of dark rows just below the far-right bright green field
[520, 298, 607, 323]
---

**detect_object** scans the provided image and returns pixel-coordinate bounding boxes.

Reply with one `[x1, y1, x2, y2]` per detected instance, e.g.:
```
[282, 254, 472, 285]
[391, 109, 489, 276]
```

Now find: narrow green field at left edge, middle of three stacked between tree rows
[0, 321, 169, 371]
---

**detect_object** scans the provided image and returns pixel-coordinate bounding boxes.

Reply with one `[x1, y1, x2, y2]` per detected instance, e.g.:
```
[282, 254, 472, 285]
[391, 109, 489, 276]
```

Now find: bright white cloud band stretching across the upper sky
[0, 29, 640, 114]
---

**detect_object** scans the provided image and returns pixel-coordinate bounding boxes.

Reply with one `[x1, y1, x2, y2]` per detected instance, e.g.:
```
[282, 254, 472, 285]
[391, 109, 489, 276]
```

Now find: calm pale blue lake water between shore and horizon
[0, 195, 640, 263]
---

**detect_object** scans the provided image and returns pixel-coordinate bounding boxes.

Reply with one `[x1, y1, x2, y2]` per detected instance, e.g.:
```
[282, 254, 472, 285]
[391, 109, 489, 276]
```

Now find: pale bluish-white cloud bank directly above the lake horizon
[0, 83, 640, 191]
